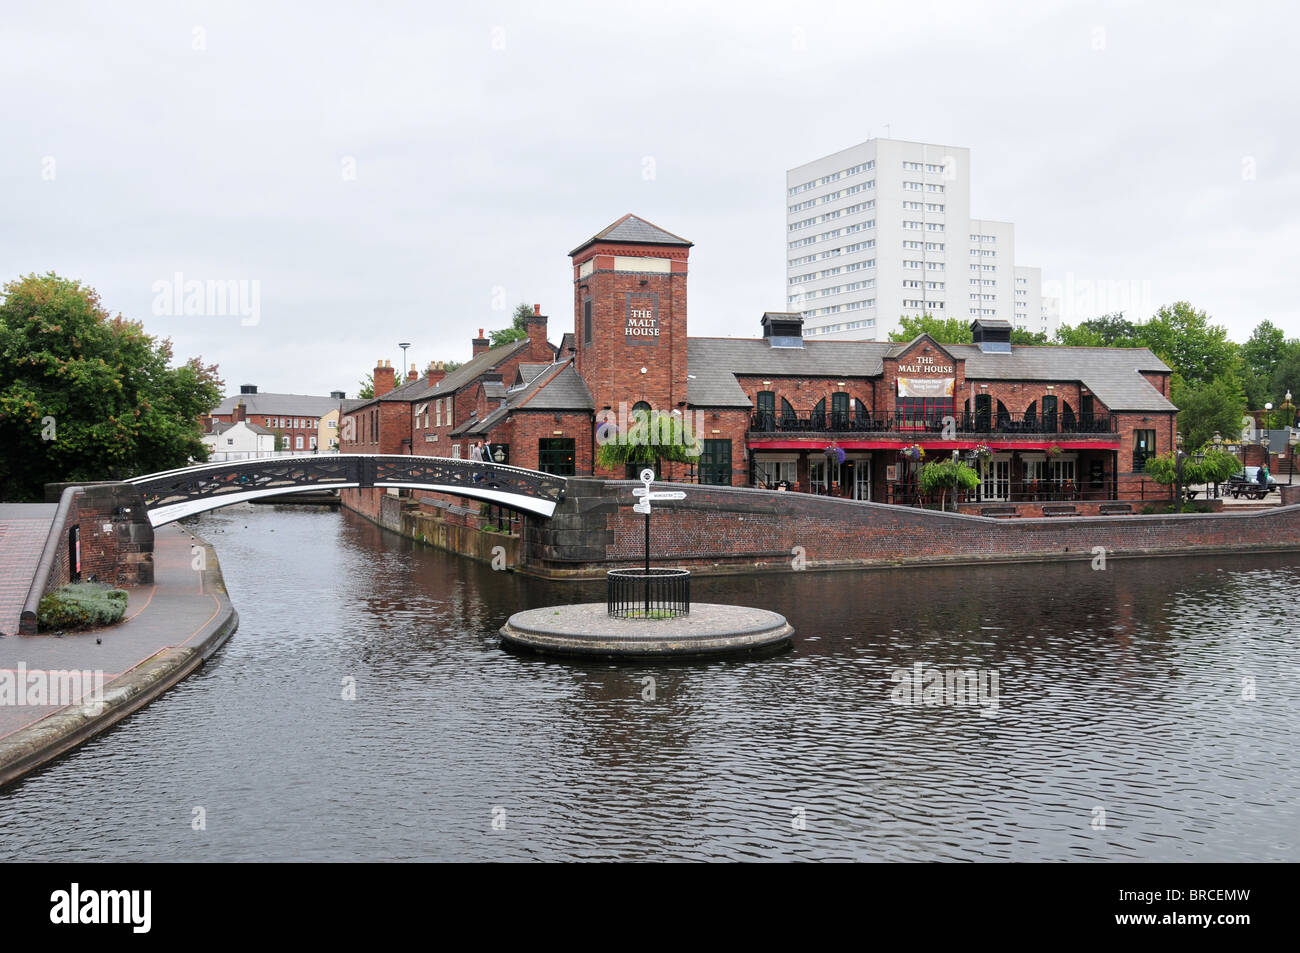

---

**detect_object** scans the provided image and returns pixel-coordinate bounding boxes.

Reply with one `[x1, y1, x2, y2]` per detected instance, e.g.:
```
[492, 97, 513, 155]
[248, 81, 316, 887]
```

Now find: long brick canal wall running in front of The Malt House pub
[523, 480, 1300, 577]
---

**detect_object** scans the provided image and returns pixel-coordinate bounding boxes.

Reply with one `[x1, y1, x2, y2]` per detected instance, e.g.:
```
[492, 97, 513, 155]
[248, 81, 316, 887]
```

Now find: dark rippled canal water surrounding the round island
[0, 507, 1300, 861]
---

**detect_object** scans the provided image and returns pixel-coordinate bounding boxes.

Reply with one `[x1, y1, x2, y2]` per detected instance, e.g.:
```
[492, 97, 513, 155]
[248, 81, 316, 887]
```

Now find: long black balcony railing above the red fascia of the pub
[750, 411, 1115, 434]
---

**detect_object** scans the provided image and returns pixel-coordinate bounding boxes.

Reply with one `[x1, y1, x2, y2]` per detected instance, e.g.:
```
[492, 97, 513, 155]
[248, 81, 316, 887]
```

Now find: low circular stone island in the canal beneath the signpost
[501, 602, 794, 659]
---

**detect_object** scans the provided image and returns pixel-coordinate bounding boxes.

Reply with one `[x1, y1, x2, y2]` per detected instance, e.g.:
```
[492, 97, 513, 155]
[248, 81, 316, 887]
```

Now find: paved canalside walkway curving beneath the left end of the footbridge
[0, 521, 230, 745]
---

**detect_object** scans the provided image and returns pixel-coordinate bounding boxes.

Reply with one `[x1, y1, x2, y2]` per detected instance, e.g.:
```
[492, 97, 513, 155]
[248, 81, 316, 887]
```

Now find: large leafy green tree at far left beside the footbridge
[0, 273, 222, 501]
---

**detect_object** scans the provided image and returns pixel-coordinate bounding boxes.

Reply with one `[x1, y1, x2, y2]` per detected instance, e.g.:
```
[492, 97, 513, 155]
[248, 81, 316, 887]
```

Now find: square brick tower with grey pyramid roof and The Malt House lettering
[569, 215, 692, 416]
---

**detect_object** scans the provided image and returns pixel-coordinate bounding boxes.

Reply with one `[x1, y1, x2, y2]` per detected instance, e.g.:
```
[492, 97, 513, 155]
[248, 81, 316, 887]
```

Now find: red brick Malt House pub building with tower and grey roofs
[341, 215, 1177, 502]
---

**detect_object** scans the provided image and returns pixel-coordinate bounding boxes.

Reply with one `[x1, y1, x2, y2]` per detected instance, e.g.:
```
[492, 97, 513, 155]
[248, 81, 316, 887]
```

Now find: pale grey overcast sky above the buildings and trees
[0, 0, 1300, 397]
